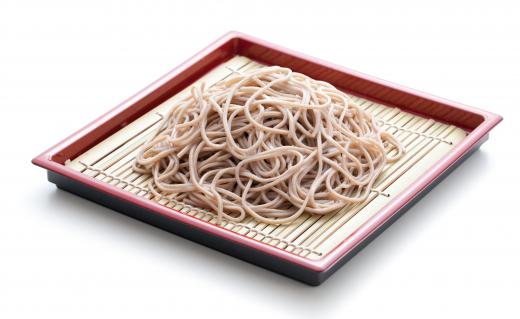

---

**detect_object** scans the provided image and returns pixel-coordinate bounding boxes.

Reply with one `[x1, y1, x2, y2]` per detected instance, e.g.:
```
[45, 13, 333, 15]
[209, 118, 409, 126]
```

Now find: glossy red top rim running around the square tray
[32, 31, 502, 272]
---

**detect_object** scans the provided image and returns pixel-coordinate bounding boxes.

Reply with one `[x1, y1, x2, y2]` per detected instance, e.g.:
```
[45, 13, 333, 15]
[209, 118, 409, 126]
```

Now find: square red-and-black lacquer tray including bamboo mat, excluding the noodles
[33, 32, 501, 285]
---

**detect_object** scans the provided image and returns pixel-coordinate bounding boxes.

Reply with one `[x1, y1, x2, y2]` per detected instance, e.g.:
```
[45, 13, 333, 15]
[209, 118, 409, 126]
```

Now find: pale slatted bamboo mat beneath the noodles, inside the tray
[66, 56, 466, 259]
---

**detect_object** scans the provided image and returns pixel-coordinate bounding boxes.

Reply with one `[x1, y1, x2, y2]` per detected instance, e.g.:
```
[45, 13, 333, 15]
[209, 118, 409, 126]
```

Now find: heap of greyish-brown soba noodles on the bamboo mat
[134, 66, 403, 224]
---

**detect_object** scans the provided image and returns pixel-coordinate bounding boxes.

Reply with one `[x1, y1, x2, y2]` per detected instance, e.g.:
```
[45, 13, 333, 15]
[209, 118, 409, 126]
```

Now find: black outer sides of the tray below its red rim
[43, 134, 489, 286]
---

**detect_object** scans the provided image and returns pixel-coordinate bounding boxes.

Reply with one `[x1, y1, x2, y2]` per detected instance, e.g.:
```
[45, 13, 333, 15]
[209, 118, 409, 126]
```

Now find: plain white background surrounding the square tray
[0, 0, 520, 318]
